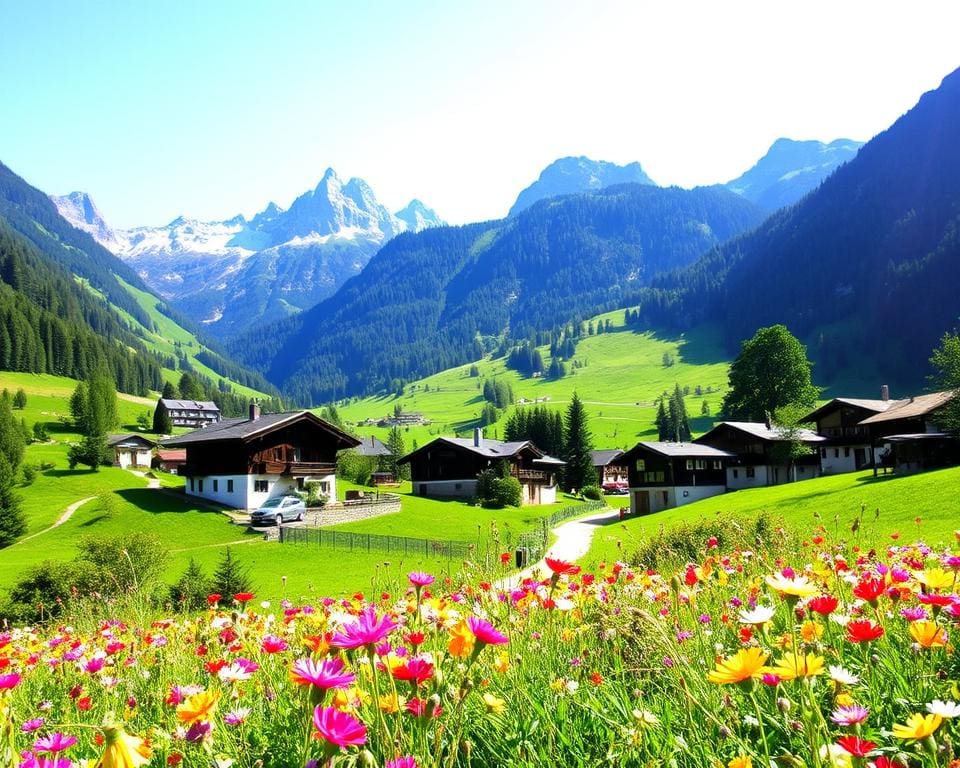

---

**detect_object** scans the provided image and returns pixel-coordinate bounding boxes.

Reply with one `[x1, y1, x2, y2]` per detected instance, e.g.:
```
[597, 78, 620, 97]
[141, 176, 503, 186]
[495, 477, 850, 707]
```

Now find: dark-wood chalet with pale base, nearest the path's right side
[618, 442, 736, 515]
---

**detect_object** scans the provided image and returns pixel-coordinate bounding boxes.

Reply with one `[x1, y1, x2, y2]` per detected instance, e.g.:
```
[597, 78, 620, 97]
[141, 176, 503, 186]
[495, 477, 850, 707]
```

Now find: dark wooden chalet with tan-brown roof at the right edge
[860, 392, 960, 474]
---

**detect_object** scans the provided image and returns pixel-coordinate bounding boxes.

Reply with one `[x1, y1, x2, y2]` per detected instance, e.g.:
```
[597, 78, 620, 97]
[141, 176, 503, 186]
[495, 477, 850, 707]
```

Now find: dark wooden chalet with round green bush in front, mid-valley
[400, 429, 564, 505]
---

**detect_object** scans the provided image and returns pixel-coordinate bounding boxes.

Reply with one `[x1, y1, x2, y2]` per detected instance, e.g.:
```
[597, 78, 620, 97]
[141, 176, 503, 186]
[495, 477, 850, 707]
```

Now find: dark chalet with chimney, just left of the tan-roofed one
[803, 396, 896, 475]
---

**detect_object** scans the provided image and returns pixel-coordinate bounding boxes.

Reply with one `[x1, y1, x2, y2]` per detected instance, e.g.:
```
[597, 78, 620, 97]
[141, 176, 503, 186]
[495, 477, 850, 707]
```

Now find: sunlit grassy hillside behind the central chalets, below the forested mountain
[338, 311, 728, 449]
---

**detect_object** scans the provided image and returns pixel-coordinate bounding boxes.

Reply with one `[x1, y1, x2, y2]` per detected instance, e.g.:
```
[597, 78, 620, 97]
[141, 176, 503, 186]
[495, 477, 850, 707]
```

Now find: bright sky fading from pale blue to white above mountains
[0, 0, 960, 227]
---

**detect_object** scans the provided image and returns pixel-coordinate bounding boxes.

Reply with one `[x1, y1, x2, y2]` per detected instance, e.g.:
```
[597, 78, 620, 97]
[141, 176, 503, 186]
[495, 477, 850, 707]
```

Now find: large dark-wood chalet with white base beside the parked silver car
[164, 405, 360, 509]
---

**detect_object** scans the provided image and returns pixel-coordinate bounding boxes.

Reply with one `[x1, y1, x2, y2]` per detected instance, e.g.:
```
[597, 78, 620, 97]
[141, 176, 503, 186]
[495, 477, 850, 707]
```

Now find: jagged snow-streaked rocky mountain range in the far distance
[52, 168, 443, 337]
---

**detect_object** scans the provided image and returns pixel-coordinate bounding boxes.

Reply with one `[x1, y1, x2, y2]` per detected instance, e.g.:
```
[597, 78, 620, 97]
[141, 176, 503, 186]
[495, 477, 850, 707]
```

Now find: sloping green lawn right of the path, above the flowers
[582, 467, 960, 565]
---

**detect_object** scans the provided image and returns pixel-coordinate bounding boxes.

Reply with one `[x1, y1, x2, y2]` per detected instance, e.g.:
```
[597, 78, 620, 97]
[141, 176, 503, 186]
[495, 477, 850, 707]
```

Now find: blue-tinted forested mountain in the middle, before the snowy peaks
[230, 184, 762, 403]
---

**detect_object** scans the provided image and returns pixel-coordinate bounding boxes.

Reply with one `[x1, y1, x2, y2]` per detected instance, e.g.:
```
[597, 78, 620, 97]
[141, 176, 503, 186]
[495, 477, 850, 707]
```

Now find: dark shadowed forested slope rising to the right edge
[632, 70, 960, 386]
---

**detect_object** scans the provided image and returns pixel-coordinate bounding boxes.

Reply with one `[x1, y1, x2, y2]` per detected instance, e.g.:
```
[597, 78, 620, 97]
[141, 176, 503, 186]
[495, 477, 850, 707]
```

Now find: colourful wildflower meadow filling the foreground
[0, 529, 960, 768]
